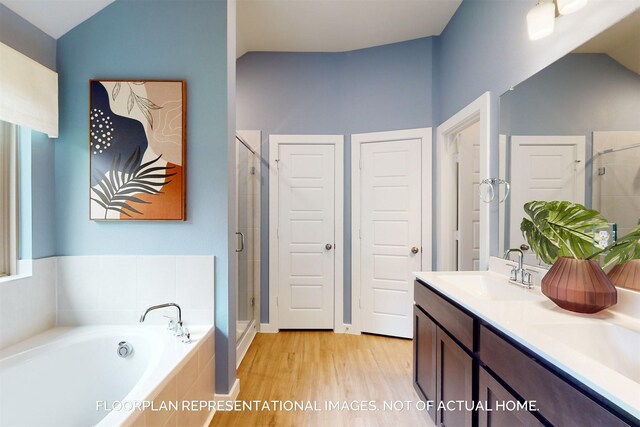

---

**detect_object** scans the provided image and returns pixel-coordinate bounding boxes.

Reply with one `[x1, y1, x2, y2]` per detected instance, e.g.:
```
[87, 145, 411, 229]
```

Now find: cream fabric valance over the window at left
[0, 43, 58, 138]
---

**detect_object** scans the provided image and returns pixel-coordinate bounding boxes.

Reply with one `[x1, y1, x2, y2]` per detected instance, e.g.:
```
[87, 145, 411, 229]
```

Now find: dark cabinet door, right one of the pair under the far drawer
[436, 328, 474, 427]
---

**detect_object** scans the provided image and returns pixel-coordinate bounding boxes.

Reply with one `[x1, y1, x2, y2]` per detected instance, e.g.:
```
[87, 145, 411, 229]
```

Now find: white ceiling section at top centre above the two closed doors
[237, 0, 462, 56]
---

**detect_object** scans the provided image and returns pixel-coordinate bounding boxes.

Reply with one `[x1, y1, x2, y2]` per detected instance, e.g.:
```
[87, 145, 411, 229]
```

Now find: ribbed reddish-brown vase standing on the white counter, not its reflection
[542, 257, 618, 313]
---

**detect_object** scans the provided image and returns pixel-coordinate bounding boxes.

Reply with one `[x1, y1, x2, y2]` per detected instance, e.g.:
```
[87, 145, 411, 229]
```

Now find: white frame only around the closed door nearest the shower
[261, 135, 345, 332]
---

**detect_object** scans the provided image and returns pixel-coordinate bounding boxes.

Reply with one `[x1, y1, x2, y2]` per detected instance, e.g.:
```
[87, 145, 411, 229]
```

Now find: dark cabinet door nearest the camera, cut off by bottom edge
[478, 368, 543, 427]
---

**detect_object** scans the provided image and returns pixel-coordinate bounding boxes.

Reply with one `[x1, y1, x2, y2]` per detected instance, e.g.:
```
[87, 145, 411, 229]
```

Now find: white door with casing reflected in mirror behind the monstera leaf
[509, 136, 585, 264]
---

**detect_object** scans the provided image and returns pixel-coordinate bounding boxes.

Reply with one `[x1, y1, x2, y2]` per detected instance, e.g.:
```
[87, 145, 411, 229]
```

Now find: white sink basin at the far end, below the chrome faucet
[434, 271, 537, 301]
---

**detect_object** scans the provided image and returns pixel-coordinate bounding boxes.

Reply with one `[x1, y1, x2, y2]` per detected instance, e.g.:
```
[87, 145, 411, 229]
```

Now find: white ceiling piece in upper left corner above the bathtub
[0, 0, 114, 39]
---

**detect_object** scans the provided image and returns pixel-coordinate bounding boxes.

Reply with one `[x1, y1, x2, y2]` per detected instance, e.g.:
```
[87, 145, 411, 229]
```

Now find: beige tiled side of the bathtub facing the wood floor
[123, 329, 215, 427]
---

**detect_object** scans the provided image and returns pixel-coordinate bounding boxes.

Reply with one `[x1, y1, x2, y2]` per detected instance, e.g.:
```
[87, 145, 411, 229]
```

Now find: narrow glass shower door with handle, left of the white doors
[236, 140, 256, 340]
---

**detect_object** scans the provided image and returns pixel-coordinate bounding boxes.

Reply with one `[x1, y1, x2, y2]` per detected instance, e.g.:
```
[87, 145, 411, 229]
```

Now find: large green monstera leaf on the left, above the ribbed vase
[520, 201, 608, 264]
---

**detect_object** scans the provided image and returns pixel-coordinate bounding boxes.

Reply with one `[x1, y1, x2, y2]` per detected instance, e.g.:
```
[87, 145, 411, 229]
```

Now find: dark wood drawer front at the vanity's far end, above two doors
[414, 280, 474, 351]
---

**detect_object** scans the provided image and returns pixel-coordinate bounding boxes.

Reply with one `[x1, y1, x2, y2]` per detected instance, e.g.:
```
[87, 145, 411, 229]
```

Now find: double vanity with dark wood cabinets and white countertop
[413, 258, 640, 427]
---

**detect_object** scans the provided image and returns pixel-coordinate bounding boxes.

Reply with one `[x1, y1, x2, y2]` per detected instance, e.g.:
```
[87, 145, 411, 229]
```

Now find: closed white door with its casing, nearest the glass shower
[268, 135, 344, 331]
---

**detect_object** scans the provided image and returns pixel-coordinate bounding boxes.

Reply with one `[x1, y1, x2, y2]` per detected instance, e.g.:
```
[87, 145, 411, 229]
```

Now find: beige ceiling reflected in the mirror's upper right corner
[574, 10, 640, 74]
